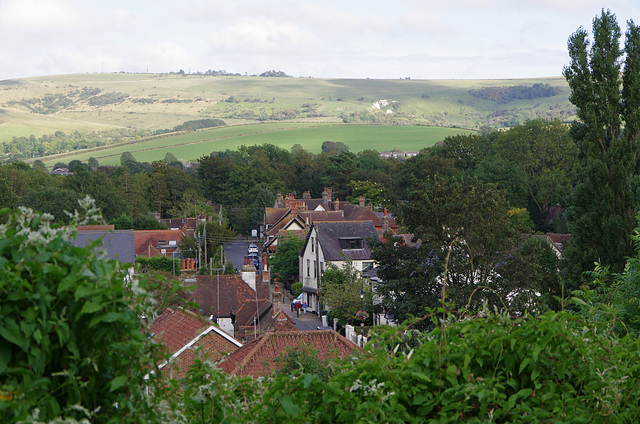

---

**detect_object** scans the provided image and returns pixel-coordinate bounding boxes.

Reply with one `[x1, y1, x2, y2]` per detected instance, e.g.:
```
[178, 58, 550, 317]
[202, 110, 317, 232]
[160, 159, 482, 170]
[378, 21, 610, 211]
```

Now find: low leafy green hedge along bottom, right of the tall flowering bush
[175, 311, 640, 423]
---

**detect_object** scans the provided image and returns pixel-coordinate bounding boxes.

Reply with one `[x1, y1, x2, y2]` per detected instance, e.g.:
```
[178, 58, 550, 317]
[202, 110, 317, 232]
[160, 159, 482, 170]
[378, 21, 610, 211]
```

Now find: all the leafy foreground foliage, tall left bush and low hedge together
[0, 205, 640, 423]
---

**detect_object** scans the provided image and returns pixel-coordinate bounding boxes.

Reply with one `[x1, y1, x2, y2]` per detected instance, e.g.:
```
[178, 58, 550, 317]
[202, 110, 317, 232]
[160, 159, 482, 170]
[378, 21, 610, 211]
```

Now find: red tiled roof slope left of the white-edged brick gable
[149, 308, 210, 353]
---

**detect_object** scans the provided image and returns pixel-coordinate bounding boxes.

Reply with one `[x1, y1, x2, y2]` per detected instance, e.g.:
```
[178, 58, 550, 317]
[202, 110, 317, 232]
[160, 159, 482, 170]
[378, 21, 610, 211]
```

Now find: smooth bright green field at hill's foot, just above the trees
[41, 123, 471, 167]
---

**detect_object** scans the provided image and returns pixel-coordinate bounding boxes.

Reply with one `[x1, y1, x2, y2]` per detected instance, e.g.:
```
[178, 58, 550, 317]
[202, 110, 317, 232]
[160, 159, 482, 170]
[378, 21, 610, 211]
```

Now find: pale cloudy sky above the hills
[0, 0, 640, 80]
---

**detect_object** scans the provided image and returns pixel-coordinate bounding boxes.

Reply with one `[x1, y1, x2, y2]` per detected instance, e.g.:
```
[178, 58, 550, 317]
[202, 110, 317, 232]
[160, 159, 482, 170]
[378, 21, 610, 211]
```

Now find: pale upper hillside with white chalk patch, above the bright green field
[0, 73, 571, 136]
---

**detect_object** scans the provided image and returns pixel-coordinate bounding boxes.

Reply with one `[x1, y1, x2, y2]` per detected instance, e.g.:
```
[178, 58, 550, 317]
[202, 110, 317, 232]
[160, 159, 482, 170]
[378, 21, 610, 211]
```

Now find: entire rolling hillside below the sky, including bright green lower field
[0, 73, 574, 163]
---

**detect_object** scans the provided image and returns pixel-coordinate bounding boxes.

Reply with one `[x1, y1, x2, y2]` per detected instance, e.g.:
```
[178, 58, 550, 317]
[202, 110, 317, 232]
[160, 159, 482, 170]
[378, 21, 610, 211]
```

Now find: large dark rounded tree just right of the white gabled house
[396, 177, 517, 312]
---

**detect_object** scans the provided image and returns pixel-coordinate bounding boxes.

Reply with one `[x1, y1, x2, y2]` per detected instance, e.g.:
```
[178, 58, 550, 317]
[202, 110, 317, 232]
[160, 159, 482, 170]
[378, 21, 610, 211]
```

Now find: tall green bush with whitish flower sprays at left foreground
[0, 209, 168, 423]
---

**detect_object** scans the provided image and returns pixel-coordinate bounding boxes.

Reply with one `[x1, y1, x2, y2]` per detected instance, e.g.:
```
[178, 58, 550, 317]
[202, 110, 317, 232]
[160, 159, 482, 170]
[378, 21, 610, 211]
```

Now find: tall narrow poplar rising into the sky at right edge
[564, 10, 640, 288]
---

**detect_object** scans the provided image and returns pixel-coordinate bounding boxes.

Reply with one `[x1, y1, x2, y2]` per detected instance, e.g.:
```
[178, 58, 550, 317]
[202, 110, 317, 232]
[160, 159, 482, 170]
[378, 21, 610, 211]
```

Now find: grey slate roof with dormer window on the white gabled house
[313, 221, 380, 261]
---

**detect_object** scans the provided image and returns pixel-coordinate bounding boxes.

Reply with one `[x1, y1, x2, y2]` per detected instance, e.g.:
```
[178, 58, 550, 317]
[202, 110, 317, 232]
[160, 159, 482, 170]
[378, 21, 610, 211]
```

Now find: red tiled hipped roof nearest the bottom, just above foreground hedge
[219, 330, 360, 378]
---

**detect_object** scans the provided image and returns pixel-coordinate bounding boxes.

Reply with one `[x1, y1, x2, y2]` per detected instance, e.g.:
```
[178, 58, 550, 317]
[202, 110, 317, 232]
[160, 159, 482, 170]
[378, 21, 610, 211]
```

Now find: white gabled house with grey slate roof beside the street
[299, 221, 380, 313]
